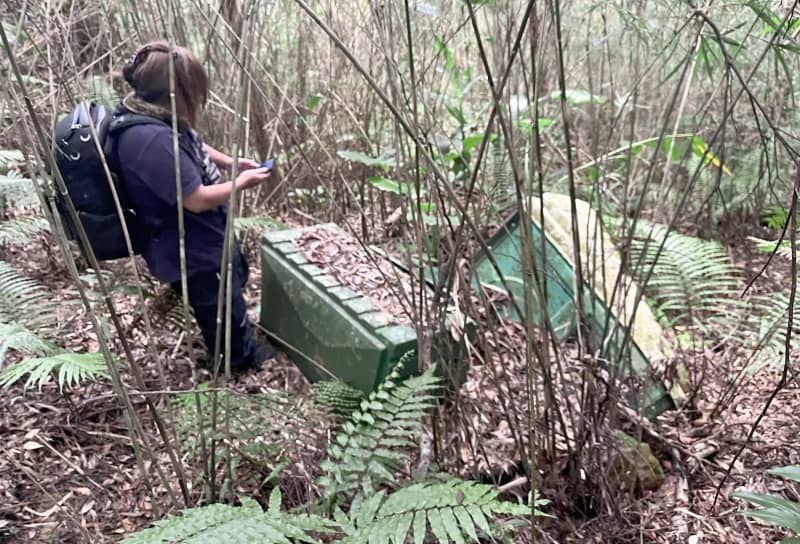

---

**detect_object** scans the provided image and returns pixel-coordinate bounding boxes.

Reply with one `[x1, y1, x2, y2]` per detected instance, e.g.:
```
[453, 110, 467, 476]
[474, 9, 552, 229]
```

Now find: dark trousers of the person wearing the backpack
[170, 248, 255, 368]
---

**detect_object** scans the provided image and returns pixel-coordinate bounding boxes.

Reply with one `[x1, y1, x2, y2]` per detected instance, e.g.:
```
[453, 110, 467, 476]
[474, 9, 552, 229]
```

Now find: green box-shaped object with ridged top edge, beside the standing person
[261, 224, 463, 393]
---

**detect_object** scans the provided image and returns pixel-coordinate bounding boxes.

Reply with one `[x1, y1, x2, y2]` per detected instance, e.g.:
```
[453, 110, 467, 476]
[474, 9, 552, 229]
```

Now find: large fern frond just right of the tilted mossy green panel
[630, 221, 738, 330]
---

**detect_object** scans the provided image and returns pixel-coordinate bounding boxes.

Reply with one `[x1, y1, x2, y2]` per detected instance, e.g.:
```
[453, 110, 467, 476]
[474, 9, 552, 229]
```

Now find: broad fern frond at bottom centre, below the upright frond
[339, 480, 547, 544]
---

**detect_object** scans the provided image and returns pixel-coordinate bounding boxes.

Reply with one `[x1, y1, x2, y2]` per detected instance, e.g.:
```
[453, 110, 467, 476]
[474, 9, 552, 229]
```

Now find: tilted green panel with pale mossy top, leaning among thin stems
[475, 194, 680, 417]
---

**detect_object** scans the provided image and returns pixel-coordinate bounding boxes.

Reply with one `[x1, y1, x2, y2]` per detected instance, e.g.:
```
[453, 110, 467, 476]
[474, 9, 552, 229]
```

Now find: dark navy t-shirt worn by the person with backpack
[115, 124, 227, 282]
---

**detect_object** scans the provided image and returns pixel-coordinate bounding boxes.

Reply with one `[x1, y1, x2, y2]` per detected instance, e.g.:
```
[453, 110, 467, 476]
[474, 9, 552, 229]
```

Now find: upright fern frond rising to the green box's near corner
[317, 356, 441, 499]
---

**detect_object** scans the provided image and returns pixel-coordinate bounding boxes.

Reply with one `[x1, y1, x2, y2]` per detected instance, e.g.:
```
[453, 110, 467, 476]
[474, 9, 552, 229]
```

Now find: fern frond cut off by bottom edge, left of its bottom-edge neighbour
[123, 491, 335, 544]
